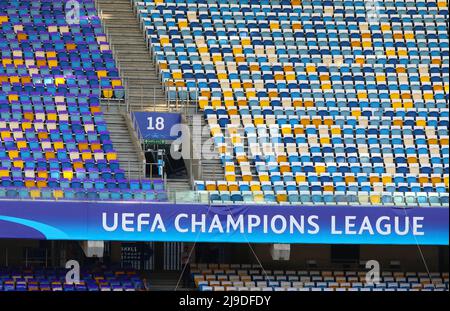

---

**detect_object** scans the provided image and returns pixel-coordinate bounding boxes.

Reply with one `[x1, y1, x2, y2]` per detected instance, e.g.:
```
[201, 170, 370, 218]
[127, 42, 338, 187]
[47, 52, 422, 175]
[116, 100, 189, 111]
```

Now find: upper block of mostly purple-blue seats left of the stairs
[0, 0, 166, 201]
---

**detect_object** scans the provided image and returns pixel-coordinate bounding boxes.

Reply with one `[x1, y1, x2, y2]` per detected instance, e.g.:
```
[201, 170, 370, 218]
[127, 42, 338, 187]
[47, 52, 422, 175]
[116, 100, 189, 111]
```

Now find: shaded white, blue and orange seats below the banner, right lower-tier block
[191, 264, 449, 291]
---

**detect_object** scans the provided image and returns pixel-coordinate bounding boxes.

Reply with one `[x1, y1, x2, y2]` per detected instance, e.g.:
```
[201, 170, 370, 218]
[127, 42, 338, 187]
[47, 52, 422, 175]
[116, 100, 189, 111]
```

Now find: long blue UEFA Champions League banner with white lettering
[0, 201, 449, 245]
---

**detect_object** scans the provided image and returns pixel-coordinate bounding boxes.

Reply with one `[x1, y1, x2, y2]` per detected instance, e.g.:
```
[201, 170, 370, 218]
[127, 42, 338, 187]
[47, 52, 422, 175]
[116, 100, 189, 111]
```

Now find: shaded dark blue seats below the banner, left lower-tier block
[0, 269, 146, 292]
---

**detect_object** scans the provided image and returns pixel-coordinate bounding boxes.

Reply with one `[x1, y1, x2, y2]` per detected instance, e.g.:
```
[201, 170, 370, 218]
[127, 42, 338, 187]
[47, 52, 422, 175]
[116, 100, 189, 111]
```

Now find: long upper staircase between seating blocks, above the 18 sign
[97, 0, 169, 111]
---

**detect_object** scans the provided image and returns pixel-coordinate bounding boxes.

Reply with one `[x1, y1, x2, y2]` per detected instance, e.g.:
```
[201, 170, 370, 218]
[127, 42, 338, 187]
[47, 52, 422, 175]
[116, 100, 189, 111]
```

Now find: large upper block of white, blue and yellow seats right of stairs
[134, 0, 449, 206]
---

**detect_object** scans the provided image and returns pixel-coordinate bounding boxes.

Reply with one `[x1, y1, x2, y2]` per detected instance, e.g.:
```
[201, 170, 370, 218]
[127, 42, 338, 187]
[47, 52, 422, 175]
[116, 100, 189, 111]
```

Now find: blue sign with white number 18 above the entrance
[133, 111, 181, 140]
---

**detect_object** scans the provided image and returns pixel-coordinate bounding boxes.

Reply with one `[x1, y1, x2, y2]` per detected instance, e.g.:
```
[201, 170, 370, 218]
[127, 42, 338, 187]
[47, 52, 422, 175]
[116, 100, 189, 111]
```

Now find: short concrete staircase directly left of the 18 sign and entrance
[103, 109, 144, 179]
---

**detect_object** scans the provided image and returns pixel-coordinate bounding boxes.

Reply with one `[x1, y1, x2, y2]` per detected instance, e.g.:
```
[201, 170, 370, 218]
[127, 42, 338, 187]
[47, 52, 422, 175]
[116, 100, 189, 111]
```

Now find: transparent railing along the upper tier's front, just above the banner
[0, 186, 449, 208]
